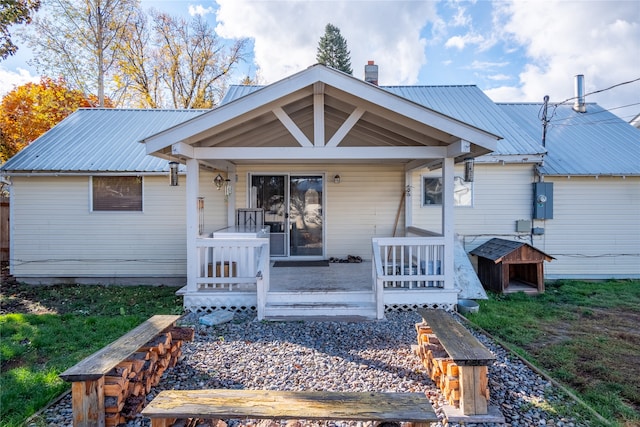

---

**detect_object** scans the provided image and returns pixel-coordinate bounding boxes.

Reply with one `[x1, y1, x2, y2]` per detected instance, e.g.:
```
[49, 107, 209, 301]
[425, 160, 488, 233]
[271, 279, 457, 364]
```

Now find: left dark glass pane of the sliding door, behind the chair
[251, 175, 287, 256]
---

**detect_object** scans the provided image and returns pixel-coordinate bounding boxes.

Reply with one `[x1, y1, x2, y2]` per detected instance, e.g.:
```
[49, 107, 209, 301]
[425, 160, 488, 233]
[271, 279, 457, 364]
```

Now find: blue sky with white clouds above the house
[0, 0, 640, 121]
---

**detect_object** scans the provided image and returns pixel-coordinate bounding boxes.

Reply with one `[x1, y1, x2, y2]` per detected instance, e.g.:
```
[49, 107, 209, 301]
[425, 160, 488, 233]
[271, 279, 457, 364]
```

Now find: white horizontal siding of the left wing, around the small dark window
[11, 173, 226, 283]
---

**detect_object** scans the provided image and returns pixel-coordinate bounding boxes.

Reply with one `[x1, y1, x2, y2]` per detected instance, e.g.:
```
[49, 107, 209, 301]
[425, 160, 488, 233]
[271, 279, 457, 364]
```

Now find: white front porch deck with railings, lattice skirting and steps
[180, 237, 458, 320]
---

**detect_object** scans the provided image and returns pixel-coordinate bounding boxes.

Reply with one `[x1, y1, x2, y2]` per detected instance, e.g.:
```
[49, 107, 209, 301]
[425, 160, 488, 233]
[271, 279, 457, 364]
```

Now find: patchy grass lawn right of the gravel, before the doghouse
[468, 280, 640, 426]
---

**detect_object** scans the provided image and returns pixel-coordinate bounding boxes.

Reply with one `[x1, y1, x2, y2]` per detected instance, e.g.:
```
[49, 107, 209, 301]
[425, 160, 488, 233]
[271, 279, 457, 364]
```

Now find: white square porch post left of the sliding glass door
[186, 159, 200, 292]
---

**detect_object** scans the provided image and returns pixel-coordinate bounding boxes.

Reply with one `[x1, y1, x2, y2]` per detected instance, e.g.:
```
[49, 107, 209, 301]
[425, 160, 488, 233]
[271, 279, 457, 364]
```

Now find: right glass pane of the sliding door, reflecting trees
[289, 175, 323, 256]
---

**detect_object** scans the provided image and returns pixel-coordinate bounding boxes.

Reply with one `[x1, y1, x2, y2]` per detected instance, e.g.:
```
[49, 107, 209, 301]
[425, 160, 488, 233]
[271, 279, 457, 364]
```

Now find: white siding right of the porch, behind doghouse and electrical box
[413, 164, 640, 279]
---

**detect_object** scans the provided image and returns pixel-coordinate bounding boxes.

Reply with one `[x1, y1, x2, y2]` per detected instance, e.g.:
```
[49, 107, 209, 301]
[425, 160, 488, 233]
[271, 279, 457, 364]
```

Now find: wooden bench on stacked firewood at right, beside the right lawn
[416, 309, 495, 416]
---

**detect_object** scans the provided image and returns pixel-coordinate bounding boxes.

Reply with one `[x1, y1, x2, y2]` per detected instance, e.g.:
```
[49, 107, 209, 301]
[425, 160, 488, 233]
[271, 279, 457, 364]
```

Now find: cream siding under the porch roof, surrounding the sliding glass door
[235, 164, 404, 259]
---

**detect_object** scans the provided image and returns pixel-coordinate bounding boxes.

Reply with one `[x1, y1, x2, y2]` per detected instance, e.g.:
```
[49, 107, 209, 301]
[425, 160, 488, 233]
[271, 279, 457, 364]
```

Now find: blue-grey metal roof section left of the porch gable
[0, 108, 208, 173]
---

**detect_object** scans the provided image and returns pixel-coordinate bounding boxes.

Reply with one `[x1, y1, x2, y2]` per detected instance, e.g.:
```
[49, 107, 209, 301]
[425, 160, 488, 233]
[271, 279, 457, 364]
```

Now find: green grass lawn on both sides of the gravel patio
[0, 281, 640, 427]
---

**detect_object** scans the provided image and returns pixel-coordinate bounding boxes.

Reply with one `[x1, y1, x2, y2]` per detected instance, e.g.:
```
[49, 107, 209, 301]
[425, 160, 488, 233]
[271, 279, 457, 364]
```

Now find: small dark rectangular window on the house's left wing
[91, 176, 142, 212]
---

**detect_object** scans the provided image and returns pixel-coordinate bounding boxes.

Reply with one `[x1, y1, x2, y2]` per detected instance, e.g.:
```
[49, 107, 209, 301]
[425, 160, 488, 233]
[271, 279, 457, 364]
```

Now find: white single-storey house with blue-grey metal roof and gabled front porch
[2, 65, 640, 318]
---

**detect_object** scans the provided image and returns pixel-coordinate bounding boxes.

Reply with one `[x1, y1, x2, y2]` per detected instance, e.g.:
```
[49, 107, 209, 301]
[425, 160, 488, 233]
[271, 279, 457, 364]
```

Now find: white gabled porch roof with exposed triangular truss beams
[143, 65, 500, 169]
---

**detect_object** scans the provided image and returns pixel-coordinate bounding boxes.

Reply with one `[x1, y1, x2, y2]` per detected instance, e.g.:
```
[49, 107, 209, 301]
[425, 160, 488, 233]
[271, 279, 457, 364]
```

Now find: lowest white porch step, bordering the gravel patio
[264, 300, 376, 321]
